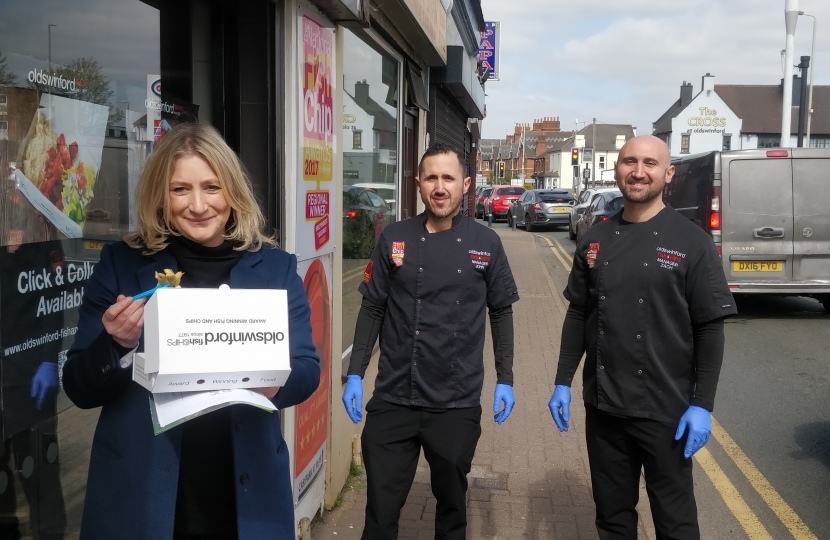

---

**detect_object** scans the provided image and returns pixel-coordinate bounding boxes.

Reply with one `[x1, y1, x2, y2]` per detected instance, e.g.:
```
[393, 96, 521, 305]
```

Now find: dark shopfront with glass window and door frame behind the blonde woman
[0, 0, 282, 539]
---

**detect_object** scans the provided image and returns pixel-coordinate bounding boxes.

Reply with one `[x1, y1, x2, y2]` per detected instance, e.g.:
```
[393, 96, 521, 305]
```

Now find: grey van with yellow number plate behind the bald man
[663, 148, 830, 312]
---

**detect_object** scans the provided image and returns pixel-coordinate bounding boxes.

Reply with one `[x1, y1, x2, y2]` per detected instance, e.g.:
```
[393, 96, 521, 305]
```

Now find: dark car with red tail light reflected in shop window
[343, 186, 394, 259]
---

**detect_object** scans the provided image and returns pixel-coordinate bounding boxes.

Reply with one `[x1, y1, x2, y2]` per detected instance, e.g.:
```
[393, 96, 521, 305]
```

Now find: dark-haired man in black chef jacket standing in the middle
[343, 144, 519, 540]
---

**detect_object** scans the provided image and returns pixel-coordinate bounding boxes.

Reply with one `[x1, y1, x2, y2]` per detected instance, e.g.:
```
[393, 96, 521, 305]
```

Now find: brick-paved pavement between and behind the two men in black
[312, 221, 654, 540]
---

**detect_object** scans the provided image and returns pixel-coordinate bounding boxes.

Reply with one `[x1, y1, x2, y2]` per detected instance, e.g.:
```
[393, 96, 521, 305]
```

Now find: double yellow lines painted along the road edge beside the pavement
[536, 234, 818, 540]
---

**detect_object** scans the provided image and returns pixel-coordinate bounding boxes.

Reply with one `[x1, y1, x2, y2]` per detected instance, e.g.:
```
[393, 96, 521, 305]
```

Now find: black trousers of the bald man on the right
[585, 405, 700, 540]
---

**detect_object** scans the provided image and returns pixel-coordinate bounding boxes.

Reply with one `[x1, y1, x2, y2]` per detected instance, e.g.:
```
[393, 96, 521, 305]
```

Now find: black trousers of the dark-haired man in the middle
[361, 397, 481, 540]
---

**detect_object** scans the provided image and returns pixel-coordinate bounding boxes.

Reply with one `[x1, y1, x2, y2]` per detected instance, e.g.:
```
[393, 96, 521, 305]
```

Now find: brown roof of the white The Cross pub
[716, 84, 830, 135]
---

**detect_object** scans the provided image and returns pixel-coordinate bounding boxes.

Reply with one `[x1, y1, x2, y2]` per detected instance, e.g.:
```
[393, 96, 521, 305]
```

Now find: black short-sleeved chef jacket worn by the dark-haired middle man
[358, 214, 519, 409]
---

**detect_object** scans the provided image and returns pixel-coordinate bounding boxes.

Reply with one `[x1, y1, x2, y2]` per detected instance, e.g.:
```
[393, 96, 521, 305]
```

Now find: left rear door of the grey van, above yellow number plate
[721, 156, 793, 288]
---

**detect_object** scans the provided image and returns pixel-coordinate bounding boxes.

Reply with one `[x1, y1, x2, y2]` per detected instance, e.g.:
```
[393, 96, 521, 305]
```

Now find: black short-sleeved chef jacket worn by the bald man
[556, 206, 737, 423]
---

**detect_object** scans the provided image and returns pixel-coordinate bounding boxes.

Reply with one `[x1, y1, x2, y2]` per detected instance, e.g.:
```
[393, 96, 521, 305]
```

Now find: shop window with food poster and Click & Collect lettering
[0, 0, 161, 538]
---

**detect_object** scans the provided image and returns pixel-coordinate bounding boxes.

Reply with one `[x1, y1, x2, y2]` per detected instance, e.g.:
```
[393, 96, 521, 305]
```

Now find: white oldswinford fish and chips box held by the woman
[133, 289, 291, 393]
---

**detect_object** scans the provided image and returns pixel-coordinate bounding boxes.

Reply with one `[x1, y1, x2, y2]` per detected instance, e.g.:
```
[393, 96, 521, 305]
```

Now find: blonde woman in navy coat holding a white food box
[63, 124, 320, 540]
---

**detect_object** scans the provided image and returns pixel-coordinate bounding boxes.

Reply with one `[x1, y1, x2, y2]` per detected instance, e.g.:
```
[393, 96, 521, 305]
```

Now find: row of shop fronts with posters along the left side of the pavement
[0, 0, 484, 538]
